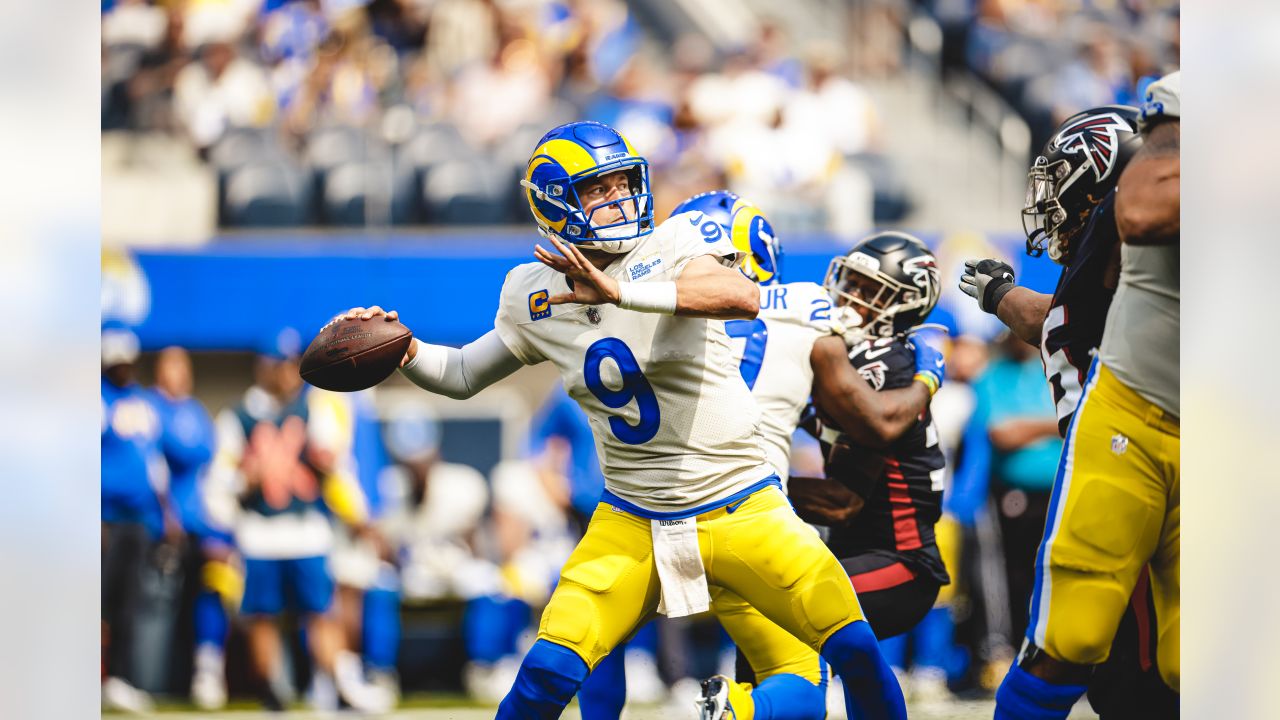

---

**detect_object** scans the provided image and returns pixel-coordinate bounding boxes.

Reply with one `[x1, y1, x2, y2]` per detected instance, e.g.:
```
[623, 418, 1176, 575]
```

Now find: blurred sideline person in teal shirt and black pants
[974, 333, 1062, 642]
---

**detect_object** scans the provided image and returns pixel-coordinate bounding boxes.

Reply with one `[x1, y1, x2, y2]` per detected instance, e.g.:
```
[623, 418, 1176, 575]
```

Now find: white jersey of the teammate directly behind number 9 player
[724, 282, 832, 479]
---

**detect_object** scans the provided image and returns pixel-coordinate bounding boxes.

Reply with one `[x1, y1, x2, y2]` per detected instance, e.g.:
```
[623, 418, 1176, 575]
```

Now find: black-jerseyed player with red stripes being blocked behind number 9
[791, 232, 950, 638]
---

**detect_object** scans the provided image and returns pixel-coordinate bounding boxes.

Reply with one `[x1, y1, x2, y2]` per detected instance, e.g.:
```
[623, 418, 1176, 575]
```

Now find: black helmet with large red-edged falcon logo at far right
[1023, 105, 1142, 265]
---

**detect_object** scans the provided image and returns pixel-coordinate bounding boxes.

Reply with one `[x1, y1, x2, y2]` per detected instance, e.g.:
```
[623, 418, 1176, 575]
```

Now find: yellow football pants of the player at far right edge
[1028, 363, 1181, 691]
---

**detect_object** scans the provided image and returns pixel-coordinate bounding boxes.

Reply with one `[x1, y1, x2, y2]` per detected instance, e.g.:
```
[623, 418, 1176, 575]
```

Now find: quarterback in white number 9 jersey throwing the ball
[335, 122, 906, 719]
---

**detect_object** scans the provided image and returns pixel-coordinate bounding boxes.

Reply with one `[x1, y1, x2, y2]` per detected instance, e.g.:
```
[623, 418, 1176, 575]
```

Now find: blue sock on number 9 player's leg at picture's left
[495, 641, 588, 720]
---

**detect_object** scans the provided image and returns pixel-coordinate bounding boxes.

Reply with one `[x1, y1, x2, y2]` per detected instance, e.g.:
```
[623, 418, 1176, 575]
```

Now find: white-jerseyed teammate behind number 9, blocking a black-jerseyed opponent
[672, 190, 943, 720]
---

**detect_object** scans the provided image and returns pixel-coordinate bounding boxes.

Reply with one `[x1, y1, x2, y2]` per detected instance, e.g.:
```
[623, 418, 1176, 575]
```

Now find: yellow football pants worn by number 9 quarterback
[538, 486, 863, 683]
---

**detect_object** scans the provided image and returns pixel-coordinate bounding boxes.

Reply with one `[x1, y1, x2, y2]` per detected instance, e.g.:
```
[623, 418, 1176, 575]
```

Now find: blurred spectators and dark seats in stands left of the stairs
[102, 0, 893, 227]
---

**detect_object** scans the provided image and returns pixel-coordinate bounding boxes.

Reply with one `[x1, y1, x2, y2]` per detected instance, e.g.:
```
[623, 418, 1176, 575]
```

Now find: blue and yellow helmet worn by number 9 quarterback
[520, 122, 653, 252]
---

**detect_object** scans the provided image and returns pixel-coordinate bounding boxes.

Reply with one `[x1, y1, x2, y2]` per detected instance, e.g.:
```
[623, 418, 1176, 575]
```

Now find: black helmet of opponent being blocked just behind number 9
[822, 232, 942, 337]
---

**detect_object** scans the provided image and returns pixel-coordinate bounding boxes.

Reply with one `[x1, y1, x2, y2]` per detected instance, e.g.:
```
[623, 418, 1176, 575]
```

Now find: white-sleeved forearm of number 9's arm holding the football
[401, 331, 522, 400]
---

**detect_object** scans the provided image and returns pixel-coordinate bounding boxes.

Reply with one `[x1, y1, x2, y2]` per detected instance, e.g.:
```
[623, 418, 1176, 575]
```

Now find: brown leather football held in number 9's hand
[298, 318, 413, 392]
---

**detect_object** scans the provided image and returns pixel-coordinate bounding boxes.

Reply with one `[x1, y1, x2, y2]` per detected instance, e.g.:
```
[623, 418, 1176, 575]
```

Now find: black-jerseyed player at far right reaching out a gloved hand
[960, 105, 1178, 720]
